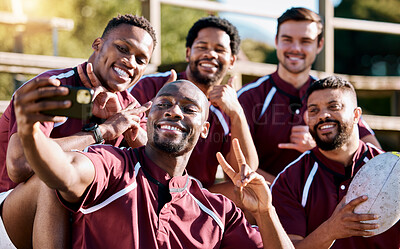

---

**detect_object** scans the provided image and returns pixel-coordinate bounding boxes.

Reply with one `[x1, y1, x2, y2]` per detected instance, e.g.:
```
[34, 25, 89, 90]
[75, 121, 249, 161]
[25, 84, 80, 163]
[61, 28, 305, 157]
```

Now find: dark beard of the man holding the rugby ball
[310, 119, 353, 151]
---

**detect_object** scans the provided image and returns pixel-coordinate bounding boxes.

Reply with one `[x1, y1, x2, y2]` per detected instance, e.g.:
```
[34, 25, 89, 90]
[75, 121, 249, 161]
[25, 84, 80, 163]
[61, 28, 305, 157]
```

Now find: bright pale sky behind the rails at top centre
[219, 0, 341, 45]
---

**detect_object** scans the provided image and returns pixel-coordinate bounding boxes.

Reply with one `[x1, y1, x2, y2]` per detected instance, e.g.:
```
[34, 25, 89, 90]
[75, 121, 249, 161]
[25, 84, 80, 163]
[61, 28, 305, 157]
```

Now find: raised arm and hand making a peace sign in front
[217, 139, 294, 248]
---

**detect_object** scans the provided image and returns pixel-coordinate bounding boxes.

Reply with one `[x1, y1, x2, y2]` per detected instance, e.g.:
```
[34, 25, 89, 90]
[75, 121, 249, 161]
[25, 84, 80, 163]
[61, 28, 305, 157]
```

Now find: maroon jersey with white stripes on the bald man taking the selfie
[64, 145, 263, 249]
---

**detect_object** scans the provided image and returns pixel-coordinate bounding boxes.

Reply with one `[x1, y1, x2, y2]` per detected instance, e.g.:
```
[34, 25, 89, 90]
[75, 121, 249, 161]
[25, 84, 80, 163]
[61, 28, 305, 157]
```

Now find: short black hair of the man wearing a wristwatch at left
[101, 14, 157, 49]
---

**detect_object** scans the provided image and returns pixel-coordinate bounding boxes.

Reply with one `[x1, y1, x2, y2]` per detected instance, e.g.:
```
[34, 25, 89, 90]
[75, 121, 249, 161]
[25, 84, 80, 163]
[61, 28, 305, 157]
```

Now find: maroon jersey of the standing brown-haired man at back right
[238, 72, 373, 176]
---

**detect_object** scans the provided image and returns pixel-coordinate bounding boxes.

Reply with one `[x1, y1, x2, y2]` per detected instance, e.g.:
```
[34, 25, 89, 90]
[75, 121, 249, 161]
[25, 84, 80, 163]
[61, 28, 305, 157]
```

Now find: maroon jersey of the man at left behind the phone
[0, 63, 141, 192]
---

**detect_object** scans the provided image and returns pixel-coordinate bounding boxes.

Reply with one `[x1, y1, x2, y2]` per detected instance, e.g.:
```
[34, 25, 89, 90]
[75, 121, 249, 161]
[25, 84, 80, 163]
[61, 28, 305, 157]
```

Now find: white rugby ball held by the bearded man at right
[346, 152, 400, 235]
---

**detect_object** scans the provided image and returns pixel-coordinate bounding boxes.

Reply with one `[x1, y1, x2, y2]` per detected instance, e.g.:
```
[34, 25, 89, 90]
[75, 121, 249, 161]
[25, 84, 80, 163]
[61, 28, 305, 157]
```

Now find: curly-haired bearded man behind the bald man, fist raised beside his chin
[131, 16, 258, 189]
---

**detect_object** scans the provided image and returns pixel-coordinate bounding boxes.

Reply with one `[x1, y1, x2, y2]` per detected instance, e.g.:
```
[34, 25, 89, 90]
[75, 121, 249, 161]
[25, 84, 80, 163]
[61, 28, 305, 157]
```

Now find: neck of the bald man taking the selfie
[145, 144, 191, 177]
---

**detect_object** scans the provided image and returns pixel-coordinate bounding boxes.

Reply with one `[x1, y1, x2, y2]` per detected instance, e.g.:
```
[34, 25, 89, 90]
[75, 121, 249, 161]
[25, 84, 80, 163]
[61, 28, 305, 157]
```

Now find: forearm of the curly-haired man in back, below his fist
[227, 107, 258, 170]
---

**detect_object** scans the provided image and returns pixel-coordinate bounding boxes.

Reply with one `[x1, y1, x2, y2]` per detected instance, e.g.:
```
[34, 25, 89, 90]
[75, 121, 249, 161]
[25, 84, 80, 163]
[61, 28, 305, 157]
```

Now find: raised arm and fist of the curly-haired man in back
[209, 78, 258, 170]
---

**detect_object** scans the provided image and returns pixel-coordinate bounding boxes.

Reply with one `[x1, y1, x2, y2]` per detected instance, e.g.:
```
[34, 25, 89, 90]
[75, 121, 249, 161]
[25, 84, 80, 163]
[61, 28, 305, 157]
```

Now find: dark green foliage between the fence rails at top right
[335, 0, 400, 76]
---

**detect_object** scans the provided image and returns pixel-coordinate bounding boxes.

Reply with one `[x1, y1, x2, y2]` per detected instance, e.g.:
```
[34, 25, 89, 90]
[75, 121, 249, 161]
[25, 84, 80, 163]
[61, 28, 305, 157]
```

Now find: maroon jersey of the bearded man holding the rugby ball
[271, 141, 400, 249]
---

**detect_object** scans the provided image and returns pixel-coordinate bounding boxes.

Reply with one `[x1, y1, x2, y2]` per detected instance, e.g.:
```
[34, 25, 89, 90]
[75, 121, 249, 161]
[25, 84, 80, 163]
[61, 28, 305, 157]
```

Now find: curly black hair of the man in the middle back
[186, 16, 240, 55]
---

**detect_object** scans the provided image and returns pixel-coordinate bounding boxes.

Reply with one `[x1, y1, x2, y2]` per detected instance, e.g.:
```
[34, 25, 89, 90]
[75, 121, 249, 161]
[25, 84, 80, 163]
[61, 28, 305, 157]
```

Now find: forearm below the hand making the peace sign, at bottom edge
[253, 206, 294, 249]
